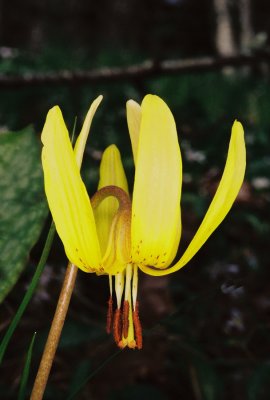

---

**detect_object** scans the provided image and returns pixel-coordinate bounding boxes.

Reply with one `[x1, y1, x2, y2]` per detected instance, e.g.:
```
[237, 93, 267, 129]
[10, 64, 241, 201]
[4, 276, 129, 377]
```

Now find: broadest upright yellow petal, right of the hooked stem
[131, 95, 182, 268]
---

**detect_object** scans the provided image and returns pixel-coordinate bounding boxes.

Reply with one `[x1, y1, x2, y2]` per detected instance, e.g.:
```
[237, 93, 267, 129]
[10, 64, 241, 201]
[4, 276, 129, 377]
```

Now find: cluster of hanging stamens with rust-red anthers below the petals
[106, 264, 142, 350]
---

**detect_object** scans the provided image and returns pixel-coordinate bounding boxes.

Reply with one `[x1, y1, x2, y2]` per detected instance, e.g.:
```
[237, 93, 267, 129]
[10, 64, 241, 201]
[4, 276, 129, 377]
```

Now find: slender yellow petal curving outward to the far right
[141, 121, 246, 276]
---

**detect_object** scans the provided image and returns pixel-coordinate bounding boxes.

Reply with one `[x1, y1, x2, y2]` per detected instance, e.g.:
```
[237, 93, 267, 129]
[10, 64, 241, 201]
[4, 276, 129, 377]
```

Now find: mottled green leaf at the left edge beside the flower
[0, 127, 48, 302]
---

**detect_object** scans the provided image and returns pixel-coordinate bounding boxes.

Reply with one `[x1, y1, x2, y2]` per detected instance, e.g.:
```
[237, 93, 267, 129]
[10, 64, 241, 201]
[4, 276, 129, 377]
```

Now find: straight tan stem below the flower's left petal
[30, 263, 78, 400]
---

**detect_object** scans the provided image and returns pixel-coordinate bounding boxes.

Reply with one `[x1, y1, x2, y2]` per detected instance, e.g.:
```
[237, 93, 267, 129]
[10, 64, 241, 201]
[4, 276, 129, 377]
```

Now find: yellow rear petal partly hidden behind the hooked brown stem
[94, 145, 128, 254]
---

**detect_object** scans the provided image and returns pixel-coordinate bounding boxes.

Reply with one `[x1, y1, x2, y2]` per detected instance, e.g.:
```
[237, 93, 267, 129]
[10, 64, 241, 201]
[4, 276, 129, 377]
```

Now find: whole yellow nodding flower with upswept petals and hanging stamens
[42, 95, 246, 349]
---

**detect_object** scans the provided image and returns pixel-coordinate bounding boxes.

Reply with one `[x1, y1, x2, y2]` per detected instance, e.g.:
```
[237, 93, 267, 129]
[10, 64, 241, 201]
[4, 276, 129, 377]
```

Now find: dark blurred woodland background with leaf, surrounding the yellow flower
[0, 0, 270, 400]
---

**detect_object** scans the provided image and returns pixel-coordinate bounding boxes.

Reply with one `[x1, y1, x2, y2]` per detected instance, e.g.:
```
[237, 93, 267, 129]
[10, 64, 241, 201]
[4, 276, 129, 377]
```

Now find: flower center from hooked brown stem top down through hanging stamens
[91, 186, 142, 349]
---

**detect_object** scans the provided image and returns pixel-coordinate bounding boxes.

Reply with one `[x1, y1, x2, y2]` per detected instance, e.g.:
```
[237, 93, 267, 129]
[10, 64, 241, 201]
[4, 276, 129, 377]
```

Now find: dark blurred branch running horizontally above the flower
[0, 53, 270, 87]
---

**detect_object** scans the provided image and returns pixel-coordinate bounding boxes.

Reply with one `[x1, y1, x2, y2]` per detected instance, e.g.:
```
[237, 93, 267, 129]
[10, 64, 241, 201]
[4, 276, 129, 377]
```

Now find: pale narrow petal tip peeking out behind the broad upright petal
[127, 100, 142, 165]
